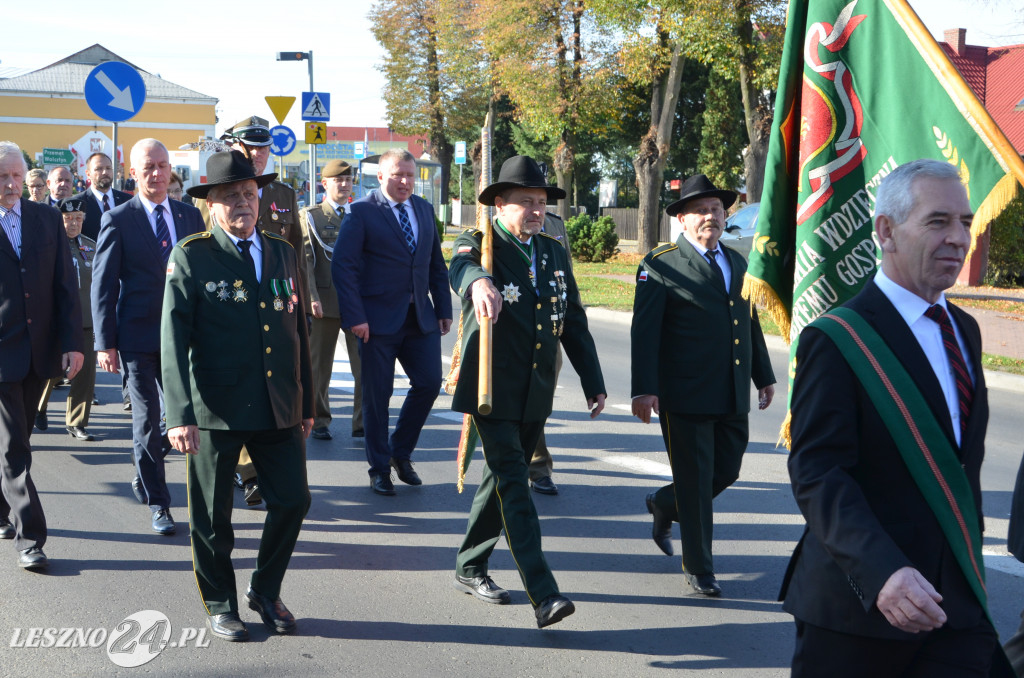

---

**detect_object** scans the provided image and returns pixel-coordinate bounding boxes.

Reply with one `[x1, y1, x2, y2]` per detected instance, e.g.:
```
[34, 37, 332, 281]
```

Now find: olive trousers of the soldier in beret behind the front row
[309, 316, 362, 433]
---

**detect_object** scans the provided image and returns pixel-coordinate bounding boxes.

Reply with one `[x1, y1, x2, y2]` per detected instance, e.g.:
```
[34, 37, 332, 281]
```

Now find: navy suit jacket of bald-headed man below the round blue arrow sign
[92, 196, 205, 352]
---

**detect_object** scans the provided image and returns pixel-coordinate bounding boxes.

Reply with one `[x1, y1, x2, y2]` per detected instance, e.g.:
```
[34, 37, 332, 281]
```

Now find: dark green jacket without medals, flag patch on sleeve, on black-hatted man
[631, 236, 775, 415]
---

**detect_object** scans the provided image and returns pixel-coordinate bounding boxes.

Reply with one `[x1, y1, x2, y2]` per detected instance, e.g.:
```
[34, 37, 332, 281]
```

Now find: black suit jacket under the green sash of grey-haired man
[779, 282, 988, 640]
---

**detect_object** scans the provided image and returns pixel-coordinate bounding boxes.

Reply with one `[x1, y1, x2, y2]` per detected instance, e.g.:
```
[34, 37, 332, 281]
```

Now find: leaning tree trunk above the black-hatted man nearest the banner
[633, 41, 683, 254]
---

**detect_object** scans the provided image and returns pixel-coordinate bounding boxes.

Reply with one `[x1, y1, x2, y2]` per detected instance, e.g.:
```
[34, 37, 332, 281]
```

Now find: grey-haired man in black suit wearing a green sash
[780, 160, 1012, 678]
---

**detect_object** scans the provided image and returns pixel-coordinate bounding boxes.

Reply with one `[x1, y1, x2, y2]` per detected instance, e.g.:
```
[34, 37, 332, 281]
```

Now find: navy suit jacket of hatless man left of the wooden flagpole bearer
[331, 189, 452, 335]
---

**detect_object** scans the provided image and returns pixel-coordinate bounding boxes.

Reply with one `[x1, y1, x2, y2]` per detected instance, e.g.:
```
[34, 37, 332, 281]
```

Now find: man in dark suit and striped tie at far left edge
[0, 141, 82, 569]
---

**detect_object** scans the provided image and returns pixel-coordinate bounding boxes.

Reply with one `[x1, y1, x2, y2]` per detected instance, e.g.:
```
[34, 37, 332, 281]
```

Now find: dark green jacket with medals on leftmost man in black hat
[161, 227, 313, 430]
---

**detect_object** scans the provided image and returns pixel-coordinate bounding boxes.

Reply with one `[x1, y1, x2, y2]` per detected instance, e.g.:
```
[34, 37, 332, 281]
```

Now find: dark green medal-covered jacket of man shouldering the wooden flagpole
[449, 227, 607, 421]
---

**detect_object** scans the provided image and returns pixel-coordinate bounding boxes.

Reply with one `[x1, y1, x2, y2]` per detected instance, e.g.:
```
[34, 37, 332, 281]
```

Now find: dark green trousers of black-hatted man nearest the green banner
[654, 410, 749, 575]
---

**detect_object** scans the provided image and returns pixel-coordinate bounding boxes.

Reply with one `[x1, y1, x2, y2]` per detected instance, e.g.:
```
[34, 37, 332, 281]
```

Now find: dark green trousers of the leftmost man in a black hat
[187, 424, 309, 615]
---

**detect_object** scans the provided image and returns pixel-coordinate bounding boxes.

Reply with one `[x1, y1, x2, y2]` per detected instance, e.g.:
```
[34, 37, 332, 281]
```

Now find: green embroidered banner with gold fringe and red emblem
[743, 0, 1024, 440]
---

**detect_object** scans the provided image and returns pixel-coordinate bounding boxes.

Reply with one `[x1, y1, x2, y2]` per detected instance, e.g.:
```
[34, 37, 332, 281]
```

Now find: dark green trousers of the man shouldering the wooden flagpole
[456, 417, 558, 607]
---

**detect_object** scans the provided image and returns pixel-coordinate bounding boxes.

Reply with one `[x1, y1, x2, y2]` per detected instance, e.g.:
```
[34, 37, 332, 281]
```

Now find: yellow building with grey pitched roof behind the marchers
[0, 44, 217, 176]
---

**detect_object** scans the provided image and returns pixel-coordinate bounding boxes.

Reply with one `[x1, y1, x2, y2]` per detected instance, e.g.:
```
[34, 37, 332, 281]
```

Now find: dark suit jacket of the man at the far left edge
[0, 198, 82, 382]
